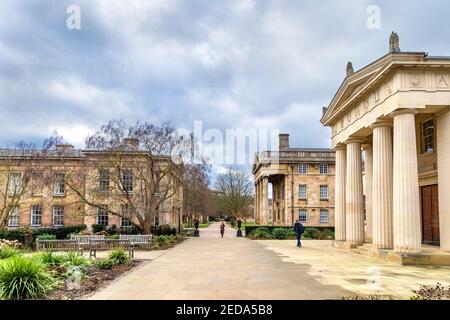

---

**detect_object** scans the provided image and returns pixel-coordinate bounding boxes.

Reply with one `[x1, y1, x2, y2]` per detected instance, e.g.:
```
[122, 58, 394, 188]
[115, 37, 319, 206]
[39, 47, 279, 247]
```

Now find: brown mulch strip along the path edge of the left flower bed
[46, 261, 142, 300]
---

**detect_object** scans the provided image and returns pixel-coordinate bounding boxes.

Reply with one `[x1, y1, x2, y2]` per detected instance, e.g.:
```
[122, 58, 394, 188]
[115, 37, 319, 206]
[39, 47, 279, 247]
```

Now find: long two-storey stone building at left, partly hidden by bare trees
[0, 139, 183, 232]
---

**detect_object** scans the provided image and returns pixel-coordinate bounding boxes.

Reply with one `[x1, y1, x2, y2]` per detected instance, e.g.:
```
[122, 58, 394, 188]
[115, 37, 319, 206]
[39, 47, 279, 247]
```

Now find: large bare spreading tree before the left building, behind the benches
[60, 120, 183, 234]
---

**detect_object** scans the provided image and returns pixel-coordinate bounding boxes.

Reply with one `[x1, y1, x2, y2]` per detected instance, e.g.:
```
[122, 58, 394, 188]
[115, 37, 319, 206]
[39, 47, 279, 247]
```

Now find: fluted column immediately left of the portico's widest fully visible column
[371, 122, 393, 249]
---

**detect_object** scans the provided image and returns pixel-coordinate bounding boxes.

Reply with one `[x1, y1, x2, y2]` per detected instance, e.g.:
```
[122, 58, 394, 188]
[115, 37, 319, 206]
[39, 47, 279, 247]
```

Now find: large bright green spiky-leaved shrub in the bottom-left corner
[0, 256, 54, 300]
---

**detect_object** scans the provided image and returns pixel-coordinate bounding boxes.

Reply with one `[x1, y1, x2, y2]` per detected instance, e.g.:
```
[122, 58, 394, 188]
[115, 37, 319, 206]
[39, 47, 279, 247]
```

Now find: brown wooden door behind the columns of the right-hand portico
[422, 185, 439, 244]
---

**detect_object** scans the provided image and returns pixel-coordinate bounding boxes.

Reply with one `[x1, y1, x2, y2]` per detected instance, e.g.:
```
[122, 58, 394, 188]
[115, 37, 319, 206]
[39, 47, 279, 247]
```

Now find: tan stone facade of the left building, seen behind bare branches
[0, 145, 183, 229]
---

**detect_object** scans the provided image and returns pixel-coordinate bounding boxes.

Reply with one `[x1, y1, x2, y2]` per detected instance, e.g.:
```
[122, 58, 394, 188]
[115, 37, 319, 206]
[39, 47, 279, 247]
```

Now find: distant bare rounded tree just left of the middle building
[216, 168, 253, 221]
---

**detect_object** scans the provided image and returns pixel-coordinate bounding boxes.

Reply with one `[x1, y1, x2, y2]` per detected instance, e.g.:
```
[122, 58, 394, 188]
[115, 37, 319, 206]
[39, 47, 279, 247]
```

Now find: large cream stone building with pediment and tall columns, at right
[321, 33, 450, 255]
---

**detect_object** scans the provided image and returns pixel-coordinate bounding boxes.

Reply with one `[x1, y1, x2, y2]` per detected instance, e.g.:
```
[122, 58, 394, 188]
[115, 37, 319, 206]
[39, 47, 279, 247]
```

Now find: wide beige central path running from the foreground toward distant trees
[91, 223, 353, 300]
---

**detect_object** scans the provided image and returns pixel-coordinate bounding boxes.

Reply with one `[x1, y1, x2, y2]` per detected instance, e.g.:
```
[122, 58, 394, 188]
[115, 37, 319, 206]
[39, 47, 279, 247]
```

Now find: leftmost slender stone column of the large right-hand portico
[334, 145, 347, 241]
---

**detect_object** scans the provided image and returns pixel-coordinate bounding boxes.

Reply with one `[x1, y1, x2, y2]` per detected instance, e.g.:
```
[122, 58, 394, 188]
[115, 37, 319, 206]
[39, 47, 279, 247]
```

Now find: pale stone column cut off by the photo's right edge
[436, 109, 450, 251]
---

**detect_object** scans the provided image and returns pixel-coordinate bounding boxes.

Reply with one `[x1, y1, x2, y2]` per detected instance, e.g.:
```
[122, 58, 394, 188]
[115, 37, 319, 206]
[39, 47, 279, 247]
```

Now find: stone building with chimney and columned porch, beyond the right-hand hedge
[253, 134, 335, 227]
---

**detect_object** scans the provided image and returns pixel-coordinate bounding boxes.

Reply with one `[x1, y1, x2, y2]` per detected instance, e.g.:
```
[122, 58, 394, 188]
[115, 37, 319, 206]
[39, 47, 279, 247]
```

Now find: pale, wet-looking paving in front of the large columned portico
[256, 240, 450, 299]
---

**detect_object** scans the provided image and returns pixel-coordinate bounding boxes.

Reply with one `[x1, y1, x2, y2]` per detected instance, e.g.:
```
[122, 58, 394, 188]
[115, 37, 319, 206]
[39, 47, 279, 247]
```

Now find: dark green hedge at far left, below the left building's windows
[0, 224, 86, 246]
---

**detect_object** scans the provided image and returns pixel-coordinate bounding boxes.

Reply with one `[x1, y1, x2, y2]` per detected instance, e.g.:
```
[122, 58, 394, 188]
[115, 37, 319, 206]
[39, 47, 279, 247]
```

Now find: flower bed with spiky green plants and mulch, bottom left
[0, 245, 141, 300]
